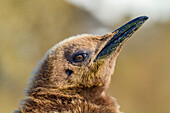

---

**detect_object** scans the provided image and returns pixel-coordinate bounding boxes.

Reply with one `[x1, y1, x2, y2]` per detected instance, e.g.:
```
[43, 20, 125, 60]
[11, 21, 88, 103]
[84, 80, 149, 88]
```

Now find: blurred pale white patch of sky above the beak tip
[66, 0, 170, 25]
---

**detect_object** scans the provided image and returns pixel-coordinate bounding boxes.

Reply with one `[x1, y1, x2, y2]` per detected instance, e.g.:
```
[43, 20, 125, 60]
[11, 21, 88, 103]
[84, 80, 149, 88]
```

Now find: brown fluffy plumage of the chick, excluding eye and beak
[16, 34, 121, 113]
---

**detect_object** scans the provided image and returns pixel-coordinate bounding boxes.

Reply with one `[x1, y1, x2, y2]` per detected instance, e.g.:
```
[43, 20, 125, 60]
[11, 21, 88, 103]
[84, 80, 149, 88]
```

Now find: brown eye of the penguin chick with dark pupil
[73, 53, 88, 62]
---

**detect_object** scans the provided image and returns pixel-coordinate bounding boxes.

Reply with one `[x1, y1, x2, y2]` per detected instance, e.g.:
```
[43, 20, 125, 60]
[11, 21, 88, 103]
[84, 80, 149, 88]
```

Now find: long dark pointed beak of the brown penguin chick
[94, 16, 148, 61]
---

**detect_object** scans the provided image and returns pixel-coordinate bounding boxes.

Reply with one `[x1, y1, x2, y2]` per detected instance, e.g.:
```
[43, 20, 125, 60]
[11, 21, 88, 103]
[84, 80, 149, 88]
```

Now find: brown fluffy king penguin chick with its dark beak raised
[15, 16, 148, 113]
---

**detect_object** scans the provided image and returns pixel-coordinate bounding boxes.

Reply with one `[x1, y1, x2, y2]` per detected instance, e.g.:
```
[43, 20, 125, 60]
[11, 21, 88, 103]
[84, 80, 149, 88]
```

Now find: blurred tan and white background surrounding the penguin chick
[0, 0, 170, 113]
